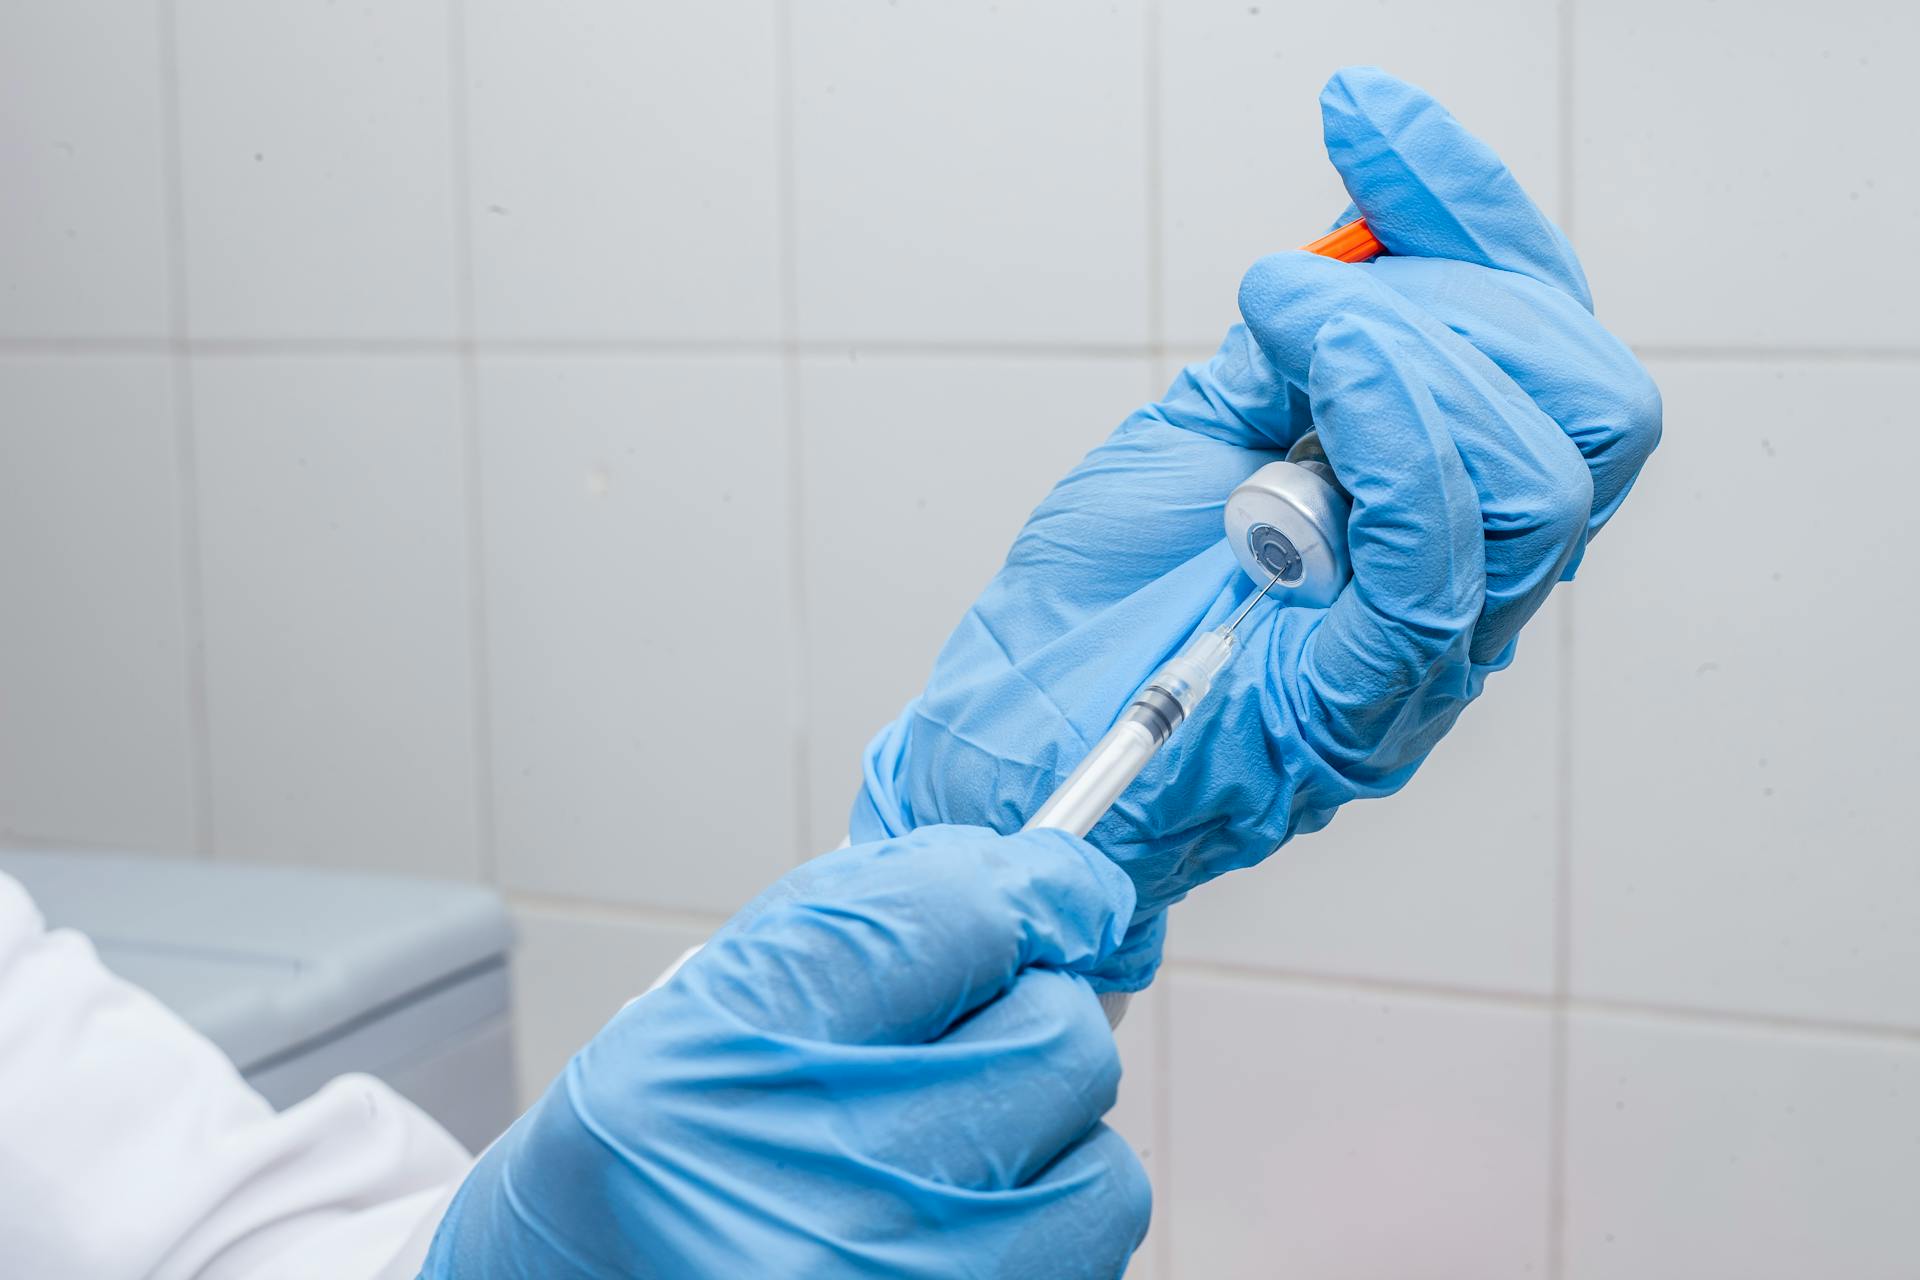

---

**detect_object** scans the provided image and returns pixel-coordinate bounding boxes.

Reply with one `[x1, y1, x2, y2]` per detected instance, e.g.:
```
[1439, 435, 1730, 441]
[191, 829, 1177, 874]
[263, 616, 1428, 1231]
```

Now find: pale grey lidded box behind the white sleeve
[0, 852, 515, 1150]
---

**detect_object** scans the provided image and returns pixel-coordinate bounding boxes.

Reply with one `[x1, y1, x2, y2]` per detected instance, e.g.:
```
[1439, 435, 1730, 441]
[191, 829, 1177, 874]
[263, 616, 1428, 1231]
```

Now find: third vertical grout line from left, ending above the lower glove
[774, 0, 818, 864]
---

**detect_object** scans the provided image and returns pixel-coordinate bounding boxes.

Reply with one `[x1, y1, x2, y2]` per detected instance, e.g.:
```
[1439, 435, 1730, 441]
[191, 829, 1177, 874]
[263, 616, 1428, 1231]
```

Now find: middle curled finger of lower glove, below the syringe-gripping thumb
[837, 969, 1119, 1192]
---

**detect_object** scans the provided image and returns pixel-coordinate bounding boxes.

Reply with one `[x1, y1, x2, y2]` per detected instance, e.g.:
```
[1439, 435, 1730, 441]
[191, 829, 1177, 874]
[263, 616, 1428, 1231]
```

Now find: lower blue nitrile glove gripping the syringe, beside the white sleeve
[422, 827, 1150, 1280]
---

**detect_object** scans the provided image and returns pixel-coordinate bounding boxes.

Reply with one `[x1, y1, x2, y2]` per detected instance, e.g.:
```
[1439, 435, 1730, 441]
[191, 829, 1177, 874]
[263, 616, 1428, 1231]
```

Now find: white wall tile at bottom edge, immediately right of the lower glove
[1162, 973, 1551, 1280]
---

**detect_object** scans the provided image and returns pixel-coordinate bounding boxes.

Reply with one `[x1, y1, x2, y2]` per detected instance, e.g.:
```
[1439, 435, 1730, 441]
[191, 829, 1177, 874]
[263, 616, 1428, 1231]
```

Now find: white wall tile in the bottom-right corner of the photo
[1565, 1015, 1920, 1280]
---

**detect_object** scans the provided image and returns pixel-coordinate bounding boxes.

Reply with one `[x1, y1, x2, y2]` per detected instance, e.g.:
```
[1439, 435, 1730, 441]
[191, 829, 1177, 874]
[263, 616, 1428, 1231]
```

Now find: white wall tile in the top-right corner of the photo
[1572, 0, 1920, 351]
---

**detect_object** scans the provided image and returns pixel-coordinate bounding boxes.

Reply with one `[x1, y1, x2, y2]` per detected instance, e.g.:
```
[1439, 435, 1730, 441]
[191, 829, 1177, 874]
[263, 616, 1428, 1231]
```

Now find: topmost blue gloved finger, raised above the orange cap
[1321, 67, 1594, 311]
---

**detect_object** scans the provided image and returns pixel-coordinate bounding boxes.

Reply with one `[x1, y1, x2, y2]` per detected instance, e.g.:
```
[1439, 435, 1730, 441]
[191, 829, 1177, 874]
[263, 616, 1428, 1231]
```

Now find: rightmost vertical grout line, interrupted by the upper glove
[1546, 0, 1578, 1280]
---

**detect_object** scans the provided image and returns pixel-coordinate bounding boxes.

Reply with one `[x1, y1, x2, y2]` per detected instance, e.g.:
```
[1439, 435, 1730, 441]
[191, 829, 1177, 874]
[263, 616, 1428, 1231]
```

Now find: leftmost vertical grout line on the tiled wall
[156, 0, 217, 858]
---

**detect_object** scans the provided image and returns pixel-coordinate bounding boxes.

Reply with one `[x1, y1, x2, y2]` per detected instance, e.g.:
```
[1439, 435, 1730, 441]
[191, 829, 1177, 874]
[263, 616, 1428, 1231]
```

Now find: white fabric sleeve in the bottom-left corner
[0, 875, 470, 1280]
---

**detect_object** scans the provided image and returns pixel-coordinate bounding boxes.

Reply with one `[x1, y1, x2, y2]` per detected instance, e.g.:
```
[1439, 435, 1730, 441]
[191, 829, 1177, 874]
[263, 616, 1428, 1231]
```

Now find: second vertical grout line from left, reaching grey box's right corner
[447, 0, 499, 885]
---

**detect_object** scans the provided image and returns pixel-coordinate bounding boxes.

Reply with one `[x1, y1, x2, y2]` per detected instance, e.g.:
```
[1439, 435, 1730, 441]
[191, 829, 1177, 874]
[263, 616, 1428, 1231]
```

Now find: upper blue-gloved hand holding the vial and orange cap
[851, 69, 1659, 990]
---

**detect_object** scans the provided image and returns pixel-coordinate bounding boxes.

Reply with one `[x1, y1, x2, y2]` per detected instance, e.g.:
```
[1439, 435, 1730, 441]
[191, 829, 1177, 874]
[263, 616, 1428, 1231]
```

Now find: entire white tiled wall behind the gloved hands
[0, 0, 1920, 1280]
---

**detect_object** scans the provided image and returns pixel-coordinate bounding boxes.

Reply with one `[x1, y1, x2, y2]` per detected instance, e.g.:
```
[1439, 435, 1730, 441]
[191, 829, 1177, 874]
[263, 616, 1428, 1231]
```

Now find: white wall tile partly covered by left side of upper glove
[801, 351, 1148, 848]
